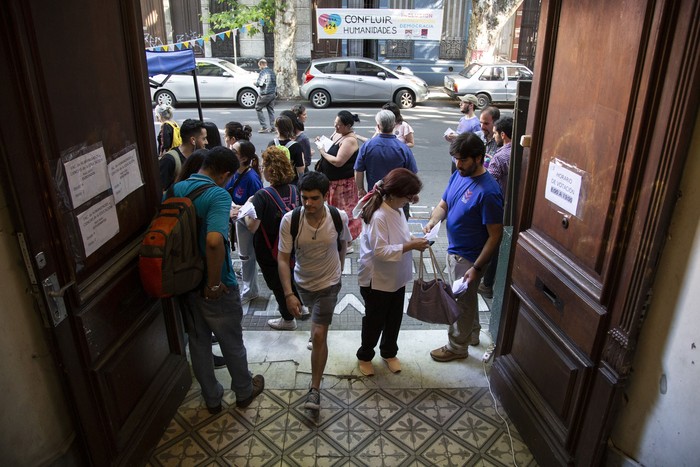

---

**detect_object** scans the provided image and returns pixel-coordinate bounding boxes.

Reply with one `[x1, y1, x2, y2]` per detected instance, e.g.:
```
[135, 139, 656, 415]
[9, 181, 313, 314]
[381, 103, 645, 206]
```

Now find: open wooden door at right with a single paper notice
[491, 0, 700, 465]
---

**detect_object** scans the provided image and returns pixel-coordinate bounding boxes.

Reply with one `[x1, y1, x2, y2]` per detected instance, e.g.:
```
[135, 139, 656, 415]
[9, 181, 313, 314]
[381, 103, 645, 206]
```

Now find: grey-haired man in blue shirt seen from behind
[355, 110, 418, 198]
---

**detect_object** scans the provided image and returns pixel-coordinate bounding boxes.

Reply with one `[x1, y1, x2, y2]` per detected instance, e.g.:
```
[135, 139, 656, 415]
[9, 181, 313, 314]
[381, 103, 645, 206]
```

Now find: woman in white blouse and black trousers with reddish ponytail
[357, 168, 428, 376]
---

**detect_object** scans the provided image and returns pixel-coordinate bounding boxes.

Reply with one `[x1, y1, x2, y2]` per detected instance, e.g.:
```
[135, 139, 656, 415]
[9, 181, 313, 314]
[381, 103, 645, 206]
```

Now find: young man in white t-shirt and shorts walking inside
[277, 172, 352, 410]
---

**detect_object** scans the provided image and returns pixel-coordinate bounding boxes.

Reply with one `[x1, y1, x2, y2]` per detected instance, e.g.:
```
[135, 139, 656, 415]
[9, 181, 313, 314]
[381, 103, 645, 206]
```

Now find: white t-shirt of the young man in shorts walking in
[277, 205, 352, 292]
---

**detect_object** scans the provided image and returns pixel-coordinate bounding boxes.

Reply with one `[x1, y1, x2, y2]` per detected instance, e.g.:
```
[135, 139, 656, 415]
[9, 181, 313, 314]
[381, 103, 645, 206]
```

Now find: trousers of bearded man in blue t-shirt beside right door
[447, 253, 481, 355]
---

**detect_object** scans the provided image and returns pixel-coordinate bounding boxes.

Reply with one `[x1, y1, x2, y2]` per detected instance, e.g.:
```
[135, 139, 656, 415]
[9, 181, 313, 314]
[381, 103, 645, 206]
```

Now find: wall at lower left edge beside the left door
[0, 187, 73, 465]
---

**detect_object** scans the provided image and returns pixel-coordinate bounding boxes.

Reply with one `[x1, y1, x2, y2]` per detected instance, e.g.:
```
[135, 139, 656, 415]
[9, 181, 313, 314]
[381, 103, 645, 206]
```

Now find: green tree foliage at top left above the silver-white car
[209, 0, 286, 36]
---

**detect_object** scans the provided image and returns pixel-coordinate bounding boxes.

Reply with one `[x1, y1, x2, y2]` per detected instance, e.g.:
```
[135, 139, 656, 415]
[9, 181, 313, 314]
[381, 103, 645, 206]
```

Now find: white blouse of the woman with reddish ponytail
[358, 202, 413, 292]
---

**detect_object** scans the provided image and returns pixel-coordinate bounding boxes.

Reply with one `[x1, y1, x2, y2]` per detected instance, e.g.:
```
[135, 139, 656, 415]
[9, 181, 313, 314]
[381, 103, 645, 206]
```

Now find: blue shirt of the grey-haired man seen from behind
[355, 133, 418, 191]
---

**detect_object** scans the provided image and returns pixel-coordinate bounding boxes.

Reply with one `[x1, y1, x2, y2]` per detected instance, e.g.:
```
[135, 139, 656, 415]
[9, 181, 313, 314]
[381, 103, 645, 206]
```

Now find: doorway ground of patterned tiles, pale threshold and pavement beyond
[147, 214, 536, 467]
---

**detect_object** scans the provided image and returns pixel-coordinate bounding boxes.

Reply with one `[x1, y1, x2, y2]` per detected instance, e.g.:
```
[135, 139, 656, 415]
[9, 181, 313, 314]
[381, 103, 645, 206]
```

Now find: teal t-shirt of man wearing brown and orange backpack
[173, 174, 237, 286]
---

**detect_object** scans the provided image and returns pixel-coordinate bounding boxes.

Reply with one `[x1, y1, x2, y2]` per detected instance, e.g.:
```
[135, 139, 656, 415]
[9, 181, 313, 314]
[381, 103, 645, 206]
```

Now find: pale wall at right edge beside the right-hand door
[612, 110, 700, 467]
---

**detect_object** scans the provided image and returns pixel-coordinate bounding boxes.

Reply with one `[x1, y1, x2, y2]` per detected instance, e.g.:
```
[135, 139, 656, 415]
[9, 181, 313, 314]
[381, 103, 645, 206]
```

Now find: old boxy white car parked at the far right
[444, 63, 532, 109]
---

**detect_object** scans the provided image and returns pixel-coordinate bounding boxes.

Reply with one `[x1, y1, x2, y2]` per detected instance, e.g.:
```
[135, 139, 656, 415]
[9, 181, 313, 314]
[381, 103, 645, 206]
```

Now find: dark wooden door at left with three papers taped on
[0, 0, 191, 465]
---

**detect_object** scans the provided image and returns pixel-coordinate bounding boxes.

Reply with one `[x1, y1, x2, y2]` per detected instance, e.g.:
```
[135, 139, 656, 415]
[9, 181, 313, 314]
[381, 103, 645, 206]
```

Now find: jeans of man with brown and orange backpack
[182, 285, 253, 407]
